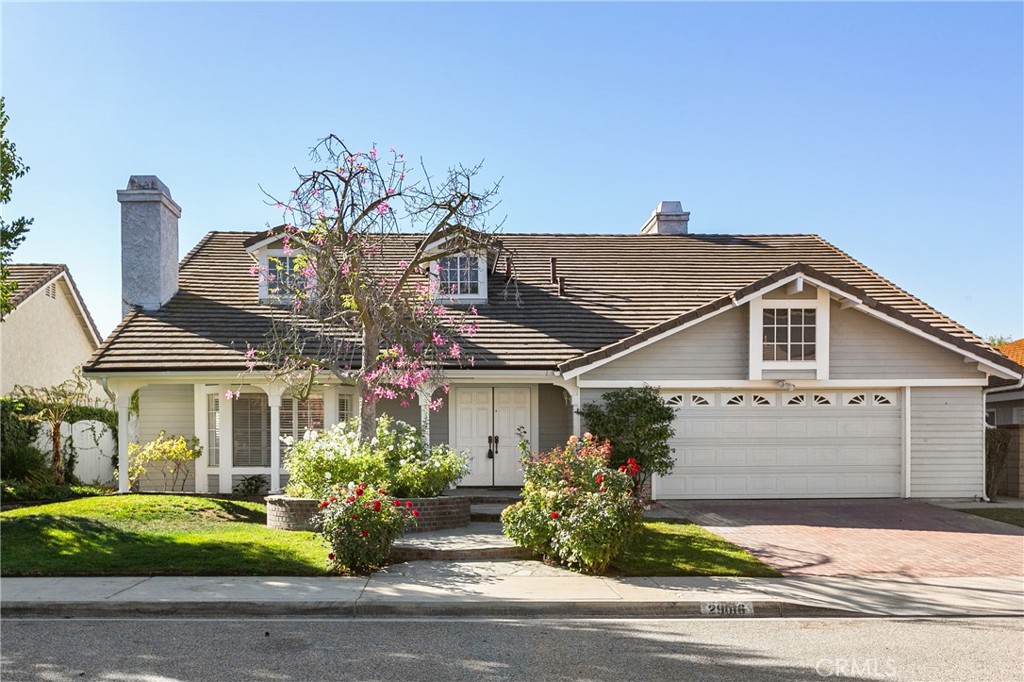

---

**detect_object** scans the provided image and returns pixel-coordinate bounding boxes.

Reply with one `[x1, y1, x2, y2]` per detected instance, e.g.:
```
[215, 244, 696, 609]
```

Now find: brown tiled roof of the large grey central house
[86, 232, 1019, 373]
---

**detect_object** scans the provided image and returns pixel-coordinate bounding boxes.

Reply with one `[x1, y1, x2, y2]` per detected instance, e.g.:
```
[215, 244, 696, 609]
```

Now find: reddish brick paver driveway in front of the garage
[664, 500, 1024, 578]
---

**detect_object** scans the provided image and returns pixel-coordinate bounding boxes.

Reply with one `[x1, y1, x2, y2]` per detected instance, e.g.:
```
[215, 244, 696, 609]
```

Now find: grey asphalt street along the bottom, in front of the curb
[0, 617, 1024, 682]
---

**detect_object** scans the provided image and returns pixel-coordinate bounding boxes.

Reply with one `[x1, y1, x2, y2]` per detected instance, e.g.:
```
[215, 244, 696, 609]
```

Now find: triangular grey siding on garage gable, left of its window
[583, 305, 750, 381]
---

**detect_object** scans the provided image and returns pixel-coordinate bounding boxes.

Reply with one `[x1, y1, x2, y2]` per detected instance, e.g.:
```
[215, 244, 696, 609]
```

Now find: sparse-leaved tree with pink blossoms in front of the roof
[256, 135, 500, 438]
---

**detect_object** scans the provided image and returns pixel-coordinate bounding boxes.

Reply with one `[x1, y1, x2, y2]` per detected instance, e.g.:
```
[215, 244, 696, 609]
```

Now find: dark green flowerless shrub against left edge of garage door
[577, 386, 676, 496]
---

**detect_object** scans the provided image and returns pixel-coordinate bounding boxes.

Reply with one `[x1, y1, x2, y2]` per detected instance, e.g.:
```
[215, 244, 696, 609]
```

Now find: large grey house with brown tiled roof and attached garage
[86, 176, 1024, 499]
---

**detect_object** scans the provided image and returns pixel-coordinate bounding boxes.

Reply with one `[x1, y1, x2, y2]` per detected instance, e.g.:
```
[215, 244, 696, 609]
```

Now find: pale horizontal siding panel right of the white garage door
[910, 386, 985, 498]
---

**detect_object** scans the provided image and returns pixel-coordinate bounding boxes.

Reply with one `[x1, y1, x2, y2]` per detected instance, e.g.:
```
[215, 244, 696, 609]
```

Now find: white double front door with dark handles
[453, 386, 531, 485]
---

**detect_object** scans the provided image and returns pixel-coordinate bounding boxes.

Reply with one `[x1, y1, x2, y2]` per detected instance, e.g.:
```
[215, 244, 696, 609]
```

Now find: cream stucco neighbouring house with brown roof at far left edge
[0, 263, 109, 402]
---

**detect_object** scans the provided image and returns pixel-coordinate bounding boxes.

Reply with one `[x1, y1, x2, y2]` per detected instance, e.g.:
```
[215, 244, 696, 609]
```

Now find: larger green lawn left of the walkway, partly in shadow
[0, 495, 327, 576]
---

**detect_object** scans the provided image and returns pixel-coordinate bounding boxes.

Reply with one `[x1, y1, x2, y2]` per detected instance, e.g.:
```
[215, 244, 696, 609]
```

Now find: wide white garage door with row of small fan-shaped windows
[654, 389, 902, 500]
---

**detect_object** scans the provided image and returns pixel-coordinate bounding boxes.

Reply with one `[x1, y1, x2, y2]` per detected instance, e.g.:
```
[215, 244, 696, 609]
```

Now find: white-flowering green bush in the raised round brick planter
[285, 416, 468, 500]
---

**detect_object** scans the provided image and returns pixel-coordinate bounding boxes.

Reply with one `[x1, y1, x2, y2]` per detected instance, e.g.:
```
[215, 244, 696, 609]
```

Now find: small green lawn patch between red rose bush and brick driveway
[612, 521, 779, 578]
